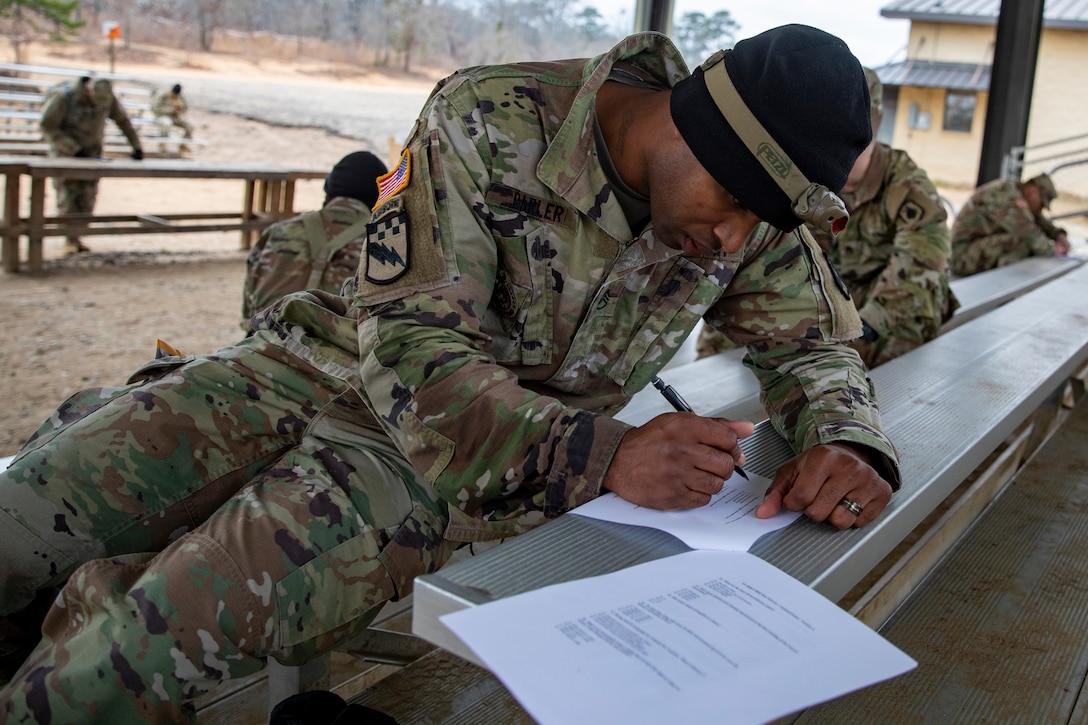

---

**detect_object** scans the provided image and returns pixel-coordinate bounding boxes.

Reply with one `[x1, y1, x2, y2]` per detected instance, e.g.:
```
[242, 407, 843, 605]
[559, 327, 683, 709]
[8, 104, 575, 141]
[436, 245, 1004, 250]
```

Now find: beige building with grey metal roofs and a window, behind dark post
[876, 0, 1088, 199]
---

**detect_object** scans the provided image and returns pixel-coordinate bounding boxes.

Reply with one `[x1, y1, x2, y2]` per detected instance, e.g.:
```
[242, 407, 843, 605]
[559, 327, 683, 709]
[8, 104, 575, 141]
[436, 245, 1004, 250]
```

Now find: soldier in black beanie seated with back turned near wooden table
[242, 151, 387, 332]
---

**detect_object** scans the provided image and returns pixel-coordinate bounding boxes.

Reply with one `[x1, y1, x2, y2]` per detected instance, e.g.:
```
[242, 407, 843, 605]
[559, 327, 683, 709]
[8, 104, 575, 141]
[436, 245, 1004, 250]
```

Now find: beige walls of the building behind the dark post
[892, 22, 1088, 203]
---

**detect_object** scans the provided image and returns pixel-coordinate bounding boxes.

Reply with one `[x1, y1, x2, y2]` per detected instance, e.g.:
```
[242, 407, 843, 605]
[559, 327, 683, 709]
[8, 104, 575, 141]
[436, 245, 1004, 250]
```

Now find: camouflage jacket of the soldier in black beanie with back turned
[242, 196, 370, 324]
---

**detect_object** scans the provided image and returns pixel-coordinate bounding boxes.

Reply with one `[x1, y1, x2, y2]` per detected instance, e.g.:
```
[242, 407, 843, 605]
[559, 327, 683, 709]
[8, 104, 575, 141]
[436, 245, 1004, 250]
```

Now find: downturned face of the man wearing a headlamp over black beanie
[648, 130, 759, 256]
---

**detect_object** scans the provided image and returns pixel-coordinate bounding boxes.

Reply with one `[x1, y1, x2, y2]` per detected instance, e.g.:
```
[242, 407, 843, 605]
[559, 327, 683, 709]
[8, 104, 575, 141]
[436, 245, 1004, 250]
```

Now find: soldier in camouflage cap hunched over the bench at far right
[952, 174, 1070, 277]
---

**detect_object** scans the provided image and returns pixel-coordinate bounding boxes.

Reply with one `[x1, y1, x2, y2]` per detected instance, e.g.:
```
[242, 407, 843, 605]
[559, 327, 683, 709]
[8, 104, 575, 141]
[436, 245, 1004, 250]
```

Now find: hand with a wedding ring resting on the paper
[755, 443, 892, 529]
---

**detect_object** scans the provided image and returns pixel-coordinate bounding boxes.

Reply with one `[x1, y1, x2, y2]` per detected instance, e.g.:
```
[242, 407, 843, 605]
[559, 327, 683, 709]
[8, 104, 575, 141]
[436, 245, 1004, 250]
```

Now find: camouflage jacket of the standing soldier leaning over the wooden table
[38, 83, 143, 158]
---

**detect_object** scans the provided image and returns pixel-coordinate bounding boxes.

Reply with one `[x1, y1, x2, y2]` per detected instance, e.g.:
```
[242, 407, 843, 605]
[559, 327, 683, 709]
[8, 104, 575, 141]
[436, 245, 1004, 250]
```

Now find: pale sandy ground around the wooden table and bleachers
[0, 40, 1088, 456]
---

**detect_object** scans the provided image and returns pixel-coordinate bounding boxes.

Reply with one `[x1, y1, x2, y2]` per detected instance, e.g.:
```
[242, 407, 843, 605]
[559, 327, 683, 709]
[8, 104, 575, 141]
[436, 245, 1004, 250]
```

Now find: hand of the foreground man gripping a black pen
[604, 413, 755, 511]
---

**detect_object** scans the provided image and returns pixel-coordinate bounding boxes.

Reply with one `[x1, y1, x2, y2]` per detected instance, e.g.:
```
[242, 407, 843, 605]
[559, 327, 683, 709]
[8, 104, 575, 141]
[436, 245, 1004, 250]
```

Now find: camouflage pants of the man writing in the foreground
[0, 339, 455, 723]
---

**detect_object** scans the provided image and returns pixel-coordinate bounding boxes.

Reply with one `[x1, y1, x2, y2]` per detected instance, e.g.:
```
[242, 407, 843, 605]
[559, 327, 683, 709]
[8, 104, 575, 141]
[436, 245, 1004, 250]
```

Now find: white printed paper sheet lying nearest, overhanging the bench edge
[441, 551, 917, 725]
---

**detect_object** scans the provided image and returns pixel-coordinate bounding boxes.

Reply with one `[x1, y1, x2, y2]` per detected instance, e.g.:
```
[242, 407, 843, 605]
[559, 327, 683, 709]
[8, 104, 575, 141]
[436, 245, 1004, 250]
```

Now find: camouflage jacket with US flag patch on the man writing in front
[250, 33, 899, 541]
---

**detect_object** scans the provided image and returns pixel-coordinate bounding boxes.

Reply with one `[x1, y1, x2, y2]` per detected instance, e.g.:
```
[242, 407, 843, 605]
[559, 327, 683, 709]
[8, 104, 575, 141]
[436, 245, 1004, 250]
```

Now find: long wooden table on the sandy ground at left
[0, 156, 329, 272]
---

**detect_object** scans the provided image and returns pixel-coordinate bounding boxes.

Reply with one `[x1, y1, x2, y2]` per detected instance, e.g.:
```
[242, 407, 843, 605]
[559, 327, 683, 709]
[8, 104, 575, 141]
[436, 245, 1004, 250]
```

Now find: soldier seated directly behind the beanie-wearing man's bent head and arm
[697, 69, 959, 368]
